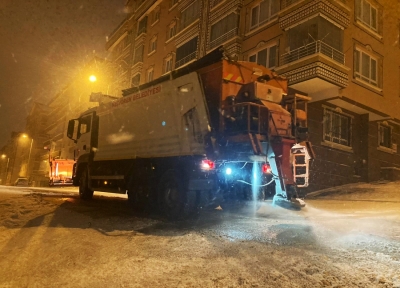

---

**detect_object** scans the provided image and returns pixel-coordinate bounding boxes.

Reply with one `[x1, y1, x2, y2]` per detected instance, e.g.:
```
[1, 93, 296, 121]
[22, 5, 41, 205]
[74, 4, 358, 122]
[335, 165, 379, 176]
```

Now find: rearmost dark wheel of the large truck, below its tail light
[158, 170, 187, 220]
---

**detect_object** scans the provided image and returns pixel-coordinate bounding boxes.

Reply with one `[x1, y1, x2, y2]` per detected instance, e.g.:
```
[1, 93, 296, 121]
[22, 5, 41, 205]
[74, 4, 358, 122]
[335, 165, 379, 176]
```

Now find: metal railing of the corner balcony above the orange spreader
[281, 40, 345, 65]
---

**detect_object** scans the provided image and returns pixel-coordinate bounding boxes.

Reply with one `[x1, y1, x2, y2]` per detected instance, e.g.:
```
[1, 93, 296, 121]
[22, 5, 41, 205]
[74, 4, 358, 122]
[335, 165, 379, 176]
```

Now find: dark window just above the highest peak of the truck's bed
[210, 13, 238, 49]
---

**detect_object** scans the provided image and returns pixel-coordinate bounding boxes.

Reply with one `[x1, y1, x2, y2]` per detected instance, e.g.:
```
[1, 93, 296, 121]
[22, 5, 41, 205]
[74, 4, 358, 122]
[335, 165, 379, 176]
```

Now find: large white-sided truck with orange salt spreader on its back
[67, 48, 313, 218]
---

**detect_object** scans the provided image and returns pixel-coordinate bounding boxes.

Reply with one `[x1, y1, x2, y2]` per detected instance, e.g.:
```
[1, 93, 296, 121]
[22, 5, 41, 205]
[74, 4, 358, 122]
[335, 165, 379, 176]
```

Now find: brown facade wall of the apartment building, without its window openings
[106, 0, 400, 191]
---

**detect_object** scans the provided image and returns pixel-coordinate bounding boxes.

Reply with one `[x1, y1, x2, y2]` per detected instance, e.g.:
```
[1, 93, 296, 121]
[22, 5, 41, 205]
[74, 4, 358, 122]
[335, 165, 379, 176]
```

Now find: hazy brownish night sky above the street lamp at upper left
[0, 0, 126, 148]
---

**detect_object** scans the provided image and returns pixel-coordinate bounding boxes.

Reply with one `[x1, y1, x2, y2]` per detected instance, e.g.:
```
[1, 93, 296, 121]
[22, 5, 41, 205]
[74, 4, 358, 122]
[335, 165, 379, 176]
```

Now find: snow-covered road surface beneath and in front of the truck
[0, 183, 400, 287]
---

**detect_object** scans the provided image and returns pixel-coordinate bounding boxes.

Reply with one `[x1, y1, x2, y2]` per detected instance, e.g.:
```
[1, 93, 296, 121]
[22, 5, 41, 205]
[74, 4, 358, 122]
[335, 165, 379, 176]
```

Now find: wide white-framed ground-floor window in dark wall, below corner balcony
[324, 109, 351, 146]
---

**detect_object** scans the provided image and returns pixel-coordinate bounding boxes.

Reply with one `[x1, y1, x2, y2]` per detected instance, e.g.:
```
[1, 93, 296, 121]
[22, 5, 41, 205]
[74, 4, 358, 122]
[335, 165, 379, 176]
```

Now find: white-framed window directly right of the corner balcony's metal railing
[354, 49, 378, 86]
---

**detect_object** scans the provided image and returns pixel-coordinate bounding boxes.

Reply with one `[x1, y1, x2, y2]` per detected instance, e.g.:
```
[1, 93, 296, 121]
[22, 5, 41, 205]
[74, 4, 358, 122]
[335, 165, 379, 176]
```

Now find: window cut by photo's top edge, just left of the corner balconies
[250, 0, 279, 30]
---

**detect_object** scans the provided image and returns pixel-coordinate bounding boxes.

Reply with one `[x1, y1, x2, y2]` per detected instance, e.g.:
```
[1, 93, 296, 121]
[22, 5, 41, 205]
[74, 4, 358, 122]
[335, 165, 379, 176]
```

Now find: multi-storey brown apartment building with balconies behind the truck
[106, 0, 400, 191]
